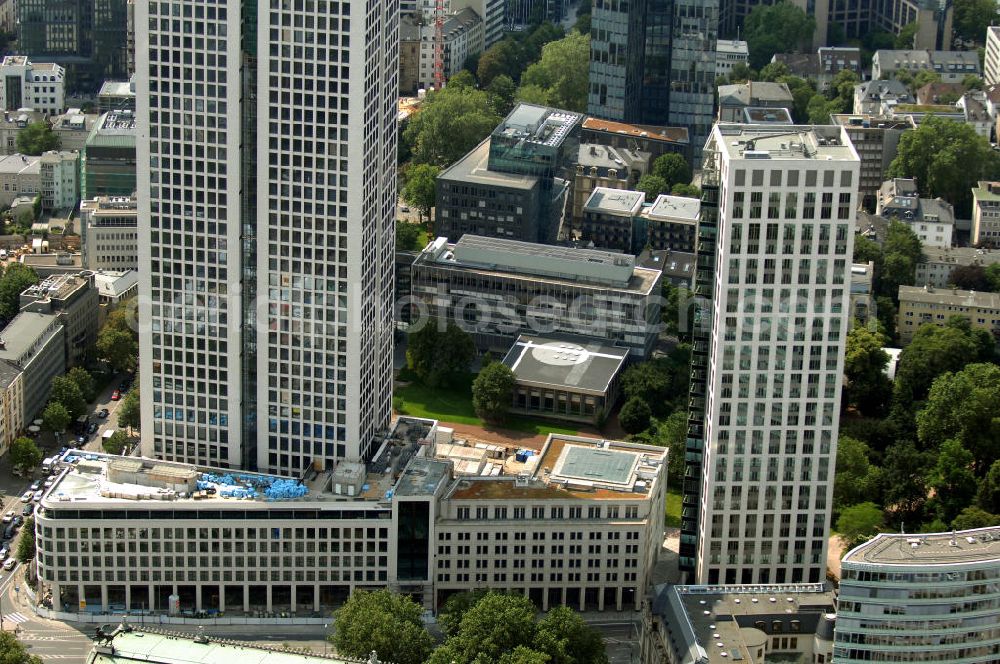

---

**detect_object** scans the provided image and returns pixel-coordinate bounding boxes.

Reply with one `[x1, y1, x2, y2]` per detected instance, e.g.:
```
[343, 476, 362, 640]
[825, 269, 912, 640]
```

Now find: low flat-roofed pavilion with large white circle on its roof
[503, 334, 629, 424]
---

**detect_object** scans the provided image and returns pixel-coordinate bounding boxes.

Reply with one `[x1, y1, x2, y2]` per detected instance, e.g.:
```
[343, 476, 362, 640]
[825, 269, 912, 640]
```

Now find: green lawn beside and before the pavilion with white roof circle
[395, 374, 579, 435]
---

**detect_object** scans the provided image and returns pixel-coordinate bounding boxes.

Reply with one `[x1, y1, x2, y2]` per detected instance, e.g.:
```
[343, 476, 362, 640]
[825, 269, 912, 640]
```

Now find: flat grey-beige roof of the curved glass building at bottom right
[842, 527, 1000, 566]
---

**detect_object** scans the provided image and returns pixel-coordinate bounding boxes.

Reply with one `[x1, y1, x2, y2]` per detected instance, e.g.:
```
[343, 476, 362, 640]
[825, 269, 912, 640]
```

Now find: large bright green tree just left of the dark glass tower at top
[517, 32, 590, 113]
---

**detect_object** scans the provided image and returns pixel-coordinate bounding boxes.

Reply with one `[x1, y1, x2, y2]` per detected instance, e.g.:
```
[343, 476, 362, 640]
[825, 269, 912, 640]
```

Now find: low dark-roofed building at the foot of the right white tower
[639, 583, 837, 664]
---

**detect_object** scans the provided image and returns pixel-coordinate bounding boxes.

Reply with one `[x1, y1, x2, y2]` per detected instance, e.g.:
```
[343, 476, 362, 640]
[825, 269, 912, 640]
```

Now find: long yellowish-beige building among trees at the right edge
[896, 286, 1000, 345]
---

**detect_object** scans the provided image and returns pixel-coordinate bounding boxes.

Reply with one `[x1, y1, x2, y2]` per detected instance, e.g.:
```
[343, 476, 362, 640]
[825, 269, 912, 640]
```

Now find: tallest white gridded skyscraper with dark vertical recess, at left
[136, 0, 399, 474]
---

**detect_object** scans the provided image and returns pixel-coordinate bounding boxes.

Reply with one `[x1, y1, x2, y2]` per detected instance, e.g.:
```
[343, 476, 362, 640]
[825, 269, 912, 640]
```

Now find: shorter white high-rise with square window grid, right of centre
[689, 125, 860, 584]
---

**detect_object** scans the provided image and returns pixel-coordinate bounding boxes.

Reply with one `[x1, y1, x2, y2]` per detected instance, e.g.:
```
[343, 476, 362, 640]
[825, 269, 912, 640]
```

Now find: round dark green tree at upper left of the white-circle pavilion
[406, 320, 476, 387]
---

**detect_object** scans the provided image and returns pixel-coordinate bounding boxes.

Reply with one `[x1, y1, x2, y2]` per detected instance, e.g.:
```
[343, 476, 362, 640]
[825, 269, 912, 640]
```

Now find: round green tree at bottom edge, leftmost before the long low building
[330, 589, 434, 664]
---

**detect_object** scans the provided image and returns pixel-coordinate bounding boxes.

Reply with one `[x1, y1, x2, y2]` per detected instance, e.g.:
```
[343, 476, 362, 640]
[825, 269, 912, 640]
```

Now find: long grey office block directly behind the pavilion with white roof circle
[411, 235, 662, 358]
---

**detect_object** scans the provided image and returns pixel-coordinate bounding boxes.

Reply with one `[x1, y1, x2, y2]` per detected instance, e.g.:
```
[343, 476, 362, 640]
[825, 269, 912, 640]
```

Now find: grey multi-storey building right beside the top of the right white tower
[830, 113, 916, 211]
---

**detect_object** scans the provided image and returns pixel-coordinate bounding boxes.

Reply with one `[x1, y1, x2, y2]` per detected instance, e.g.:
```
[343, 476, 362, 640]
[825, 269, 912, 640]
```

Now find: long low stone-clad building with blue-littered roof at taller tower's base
[36, 418, 666, 615]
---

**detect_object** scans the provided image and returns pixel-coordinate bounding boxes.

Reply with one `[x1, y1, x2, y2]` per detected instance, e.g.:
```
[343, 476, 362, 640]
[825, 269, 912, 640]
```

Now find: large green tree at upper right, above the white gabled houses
[887, 115, 1000, 219]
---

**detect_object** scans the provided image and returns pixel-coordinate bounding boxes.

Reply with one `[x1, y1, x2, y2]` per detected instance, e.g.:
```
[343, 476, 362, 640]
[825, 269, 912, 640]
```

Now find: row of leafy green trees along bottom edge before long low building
[330, 590, 608, 664]
